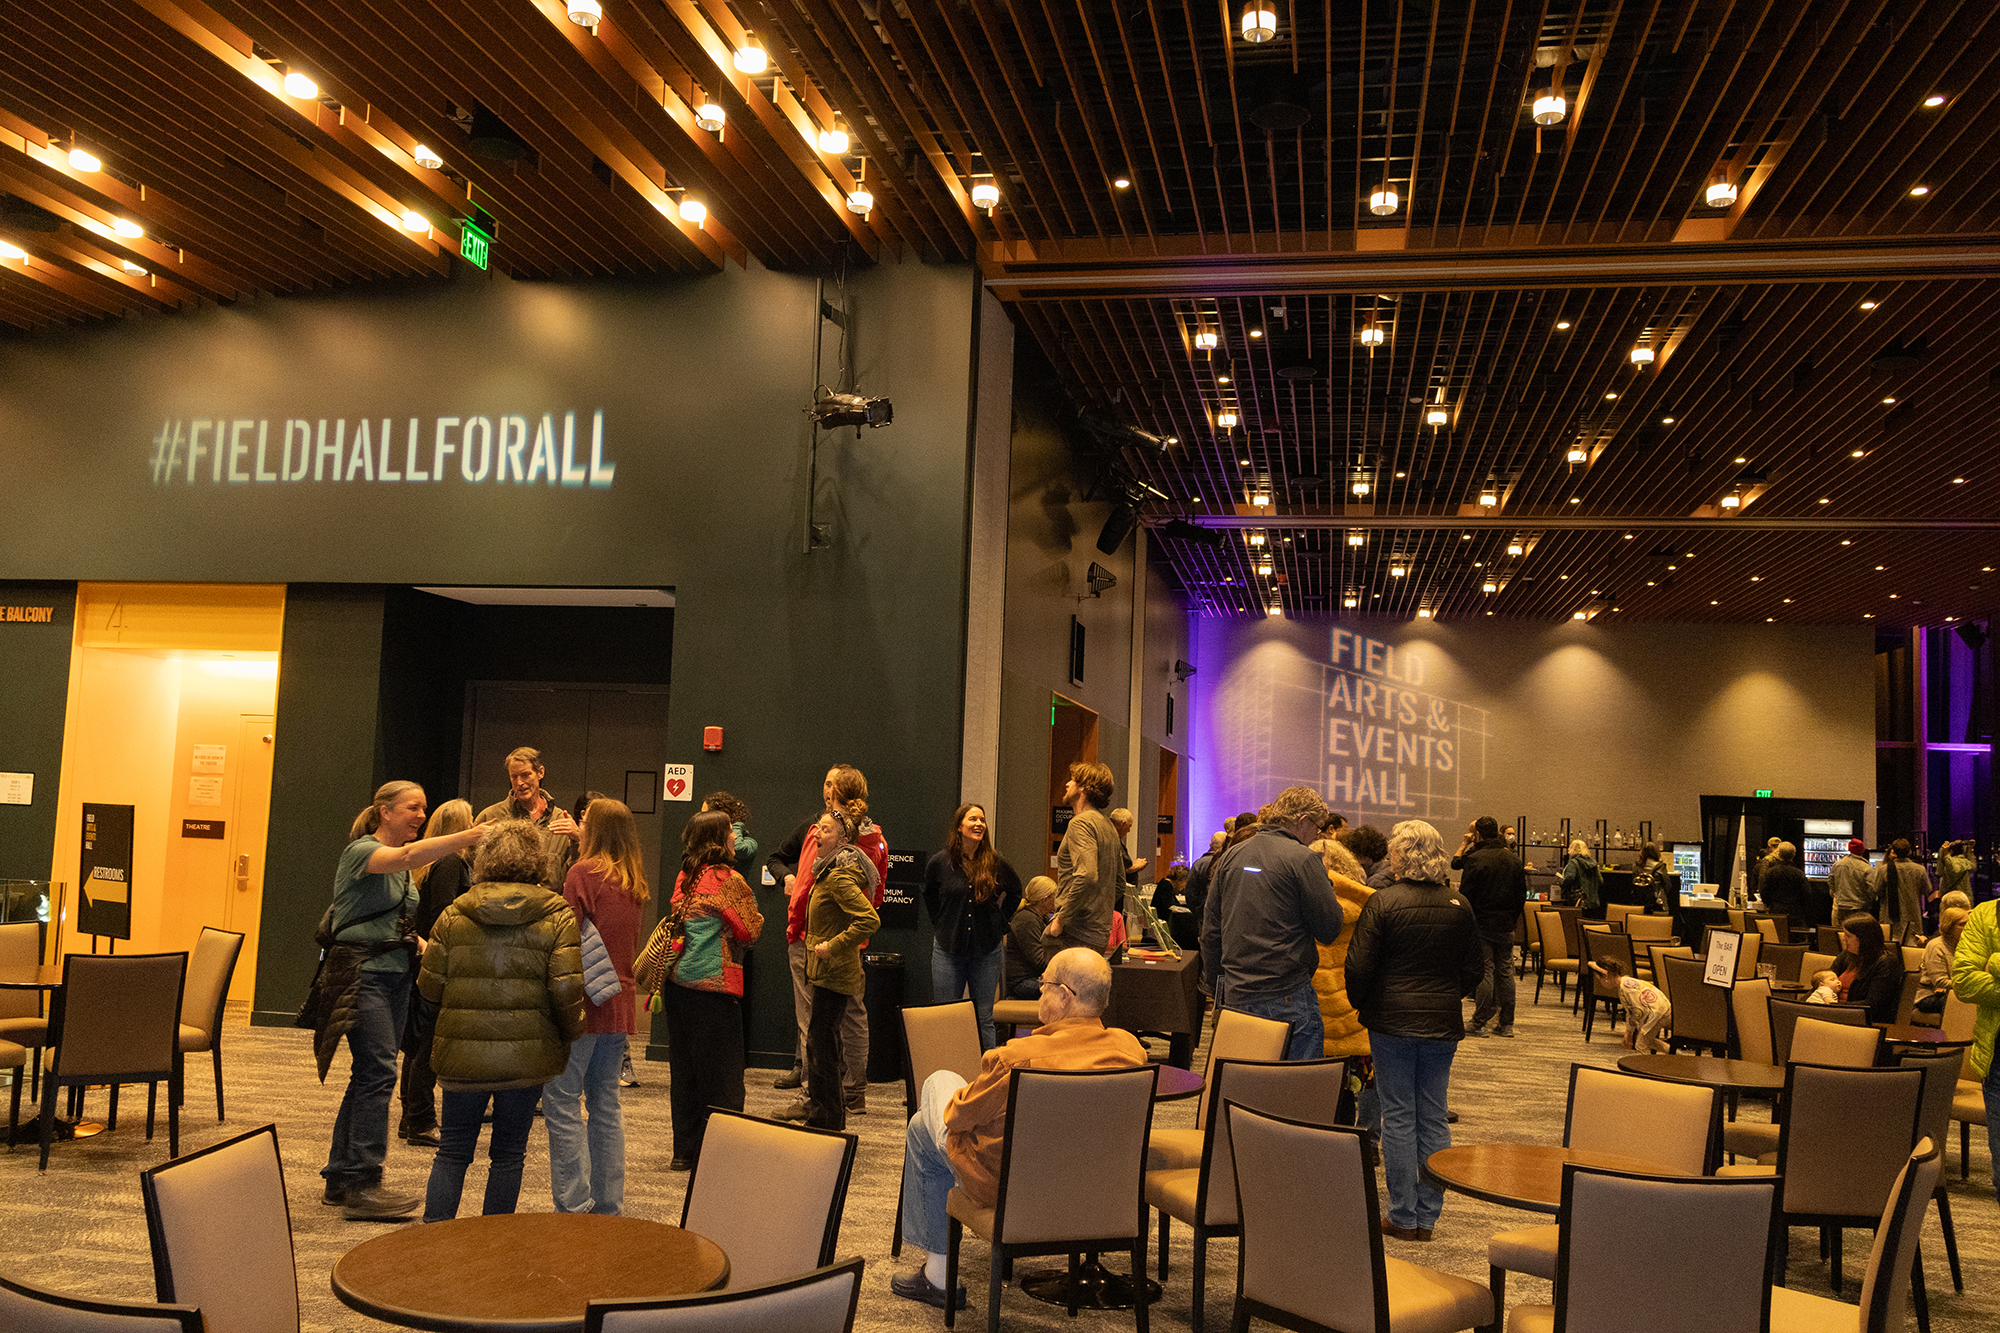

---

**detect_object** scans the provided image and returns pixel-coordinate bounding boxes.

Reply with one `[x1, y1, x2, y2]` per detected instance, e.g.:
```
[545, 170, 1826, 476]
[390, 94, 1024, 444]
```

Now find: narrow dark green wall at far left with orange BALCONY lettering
[0, 582, 76, 879]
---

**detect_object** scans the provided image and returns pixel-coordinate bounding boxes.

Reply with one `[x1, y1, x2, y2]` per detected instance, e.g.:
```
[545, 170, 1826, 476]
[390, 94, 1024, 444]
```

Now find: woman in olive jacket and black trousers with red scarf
[804, 801, 882, 1129]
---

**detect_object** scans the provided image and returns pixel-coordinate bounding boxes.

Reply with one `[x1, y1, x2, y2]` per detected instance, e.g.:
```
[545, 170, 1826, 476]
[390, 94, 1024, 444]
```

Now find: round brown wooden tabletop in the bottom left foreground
[334, 1213, 730, 1333]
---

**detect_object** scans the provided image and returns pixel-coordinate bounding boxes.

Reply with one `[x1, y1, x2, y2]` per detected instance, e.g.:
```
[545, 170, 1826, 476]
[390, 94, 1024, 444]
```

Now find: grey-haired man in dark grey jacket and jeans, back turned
[1202, 787, 1340, 1061]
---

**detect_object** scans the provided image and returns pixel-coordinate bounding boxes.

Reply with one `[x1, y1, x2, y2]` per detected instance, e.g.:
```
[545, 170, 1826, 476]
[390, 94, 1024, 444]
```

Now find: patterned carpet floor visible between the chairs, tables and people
[0, 985, 2000, 1333]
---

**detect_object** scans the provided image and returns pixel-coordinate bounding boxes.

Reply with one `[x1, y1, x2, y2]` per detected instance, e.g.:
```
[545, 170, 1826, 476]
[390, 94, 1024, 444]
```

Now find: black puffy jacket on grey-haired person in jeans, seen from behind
[1348, 879, 1486, 1041]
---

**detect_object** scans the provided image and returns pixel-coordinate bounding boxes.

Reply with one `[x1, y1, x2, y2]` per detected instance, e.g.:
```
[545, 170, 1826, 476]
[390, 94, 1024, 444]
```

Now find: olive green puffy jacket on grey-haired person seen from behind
[416, 883, 584, 1093]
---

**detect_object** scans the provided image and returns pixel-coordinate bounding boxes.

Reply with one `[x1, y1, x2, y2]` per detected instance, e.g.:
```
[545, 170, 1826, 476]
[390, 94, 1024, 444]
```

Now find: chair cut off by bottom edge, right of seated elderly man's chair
[1224, 1107, 1494, 1333]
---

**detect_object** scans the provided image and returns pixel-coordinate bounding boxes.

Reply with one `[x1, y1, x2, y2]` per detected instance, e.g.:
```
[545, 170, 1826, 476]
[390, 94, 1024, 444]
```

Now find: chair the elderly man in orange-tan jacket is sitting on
[944, 1065, 1160, 1333]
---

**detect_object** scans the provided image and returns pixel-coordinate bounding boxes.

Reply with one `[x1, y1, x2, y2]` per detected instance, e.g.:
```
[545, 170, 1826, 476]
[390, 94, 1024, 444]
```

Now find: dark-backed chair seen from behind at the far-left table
[42, 953, 188, 1171]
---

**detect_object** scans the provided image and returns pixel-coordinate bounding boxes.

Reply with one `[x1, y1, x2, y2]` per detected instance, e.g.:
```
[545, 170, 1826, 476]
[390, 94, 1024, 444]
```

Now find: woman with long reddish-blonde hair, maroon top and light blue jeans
[542, 797, 650, 1215]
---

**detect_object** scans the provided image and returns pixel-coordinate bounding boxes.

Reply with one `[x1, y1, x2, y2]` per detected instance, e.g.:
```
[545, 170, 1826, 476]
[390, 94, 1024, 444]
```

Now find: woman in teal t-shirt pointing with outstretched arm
[326, 783, 480, 1221]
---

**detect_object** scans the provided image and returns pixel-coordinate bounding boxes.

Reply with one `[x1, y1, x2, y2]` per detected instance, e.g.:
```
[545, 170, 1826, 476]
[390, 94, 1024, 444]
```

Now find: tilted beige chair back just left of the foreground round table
[138, 1125, 298, 1333]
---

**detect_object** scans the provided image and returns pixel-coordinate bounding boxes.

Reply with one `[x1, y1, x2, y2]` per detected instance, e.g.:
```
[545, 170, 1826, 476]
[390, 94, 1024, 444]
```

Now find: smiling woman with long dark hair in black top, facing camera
[924, 803, 1020, 1051]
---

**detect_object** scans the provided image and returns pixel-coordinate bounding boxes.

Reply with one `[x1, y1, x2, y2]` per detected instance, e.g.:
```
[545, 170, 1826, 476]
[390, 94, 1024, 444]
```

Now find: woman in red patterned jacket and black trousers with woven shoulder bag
[660, 811, 764, 1171]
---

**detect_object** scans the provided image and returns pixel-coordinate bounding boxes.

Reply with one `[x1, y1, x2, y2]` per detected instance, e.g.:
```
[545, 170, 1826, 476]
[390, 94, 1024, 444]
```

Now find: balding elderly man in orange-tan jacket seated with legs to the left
[890, 949, 1146, 1309]
